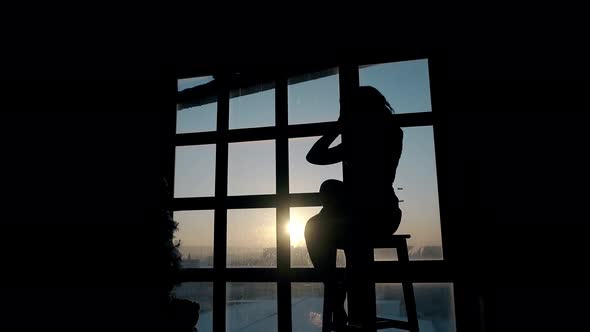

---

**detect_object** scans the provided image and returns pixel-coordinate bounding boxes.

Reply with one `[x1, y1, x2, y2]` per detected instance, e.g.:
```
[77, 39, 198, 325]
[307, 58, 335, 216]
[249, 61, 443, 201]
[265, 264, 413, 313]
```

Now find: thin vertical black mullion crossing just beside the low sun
[275, 77, 291, 332]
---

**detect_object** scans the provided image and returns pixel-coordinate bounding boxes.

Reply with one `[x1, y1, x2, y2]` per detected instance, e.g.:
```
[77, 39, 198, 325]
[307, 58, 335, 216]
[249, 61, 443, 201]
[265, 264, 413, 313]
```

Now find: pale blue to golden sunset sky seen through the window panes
[174, 60, 442, 264]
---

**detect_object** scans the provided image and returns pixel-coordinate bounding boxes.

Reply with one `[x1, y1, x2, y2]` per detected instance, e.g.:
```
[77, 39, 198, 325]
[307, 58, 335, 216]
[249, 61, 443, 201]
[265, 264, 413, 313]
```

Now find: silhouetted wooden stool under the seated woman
[322, 234, 419, 332]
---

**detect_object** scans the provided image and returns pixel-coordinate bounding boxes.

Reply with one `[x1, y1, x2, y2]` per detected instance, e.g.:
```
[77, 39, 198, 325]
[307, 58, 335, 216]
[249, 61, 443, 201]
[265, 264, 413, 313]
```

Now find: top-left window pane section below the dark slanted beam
[176, 102, 217, 134]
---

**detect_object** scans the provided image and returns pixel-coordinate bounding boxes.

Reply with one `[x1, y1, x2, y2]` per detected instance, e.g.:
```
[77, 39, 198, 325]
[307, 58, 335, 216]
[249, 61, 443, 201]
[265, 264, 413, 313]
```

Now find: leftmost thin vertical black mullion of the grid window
[213, 80, 229, 332]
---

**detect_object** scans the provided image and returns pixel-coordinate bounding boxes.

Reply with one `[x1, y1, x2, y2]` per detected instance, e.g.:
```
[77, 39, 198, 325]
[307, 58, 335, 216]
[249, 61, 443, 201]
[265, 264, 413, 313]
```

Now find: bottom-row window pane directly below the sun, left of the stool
[291, 282, 324, 332]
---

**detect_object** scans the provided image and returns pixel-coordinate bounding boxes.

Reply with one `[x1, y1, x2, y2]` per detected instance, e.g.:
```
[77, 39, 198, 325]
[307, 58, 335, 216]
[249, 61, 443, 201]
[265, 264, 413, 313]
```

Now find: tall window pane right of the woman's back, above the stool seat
[394, 126, 443, 260]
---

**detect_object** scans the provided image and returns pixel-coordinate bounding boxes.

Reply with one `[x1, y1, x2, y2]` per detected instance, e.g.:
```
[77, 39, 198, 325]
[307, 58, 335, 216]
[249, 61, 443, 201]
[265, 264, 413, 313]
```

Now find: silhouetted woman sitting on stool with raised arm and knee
[305, 86, 403, 321]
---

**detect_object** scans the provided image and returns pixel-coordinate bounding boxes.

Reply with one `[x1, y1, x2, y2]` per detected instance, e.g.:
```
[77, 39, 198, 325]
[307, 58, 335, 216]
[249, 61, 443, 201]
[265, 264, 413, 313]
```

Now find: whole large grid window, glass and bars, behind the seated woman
[171, 59, 455, 332]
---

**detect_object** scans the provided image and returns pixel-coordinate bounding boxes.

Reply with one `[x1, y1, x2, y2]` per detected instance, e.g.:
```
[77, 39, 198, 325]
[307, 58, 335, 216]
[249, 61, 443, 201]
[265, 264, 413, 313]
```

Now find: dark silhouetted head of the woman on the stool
[340, 86, 393, 123]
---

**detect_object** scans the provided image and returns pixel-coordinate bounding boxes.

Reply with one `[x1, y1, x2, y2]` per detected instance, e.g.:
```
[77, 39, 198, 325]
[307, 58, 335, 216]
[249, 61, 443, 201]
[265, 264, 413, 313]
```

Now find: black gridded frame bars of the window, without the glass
[168, 56, 456, 331]
